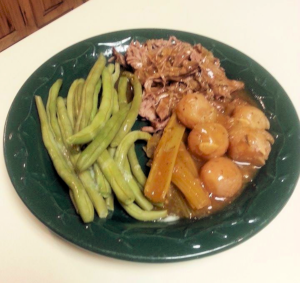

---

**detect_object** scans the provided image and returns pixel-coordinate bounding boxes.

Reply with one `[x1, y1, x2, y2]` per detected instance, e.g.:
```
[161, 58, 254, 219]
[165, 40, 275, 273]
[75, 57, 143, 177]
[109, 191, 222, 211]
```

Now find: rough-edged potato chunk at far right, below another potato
[228, 126, 274, 166]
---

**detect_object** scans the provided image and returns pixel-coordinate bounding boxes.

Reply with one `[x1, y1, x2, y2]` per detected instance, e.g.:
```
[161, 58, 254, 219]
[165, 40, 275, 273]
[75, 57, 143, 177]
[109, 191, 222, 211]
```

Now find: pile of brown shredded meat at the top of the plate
[113, 37, 244, 132]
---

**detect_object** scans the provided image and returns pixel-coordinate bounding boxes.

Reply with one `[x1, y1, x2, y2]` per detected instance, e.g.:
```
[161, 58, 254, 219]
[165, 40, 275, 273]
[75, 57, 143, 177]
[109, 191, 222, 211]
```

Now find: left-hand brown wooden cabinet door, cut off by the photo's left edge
[0, 0, 37, 52]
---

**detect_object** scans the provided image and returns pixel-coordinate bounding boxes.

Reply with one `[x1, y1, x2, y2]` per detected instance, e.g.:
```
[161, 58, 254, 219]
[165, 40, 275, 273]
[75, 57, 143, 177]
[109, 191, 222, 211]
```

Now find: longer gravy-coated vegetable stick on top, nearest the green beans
[144, 113, 185, 203]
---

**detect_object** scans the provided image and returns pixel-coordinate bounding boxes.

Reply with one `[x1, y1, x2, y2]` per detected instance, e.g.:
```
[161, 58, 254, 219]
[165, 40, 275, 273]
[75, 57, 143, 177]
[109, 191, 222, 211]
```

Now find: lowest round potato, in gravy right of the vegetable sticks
[200, 157, 243, 197]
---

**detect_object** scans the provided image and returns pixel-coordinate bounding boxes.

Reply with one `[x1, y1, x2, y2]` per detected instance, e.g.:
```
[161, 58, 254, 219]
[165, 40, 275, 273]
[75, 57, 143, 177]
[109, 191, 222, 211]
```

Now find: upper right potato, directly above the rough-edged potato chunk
[232, 105, 270, 130]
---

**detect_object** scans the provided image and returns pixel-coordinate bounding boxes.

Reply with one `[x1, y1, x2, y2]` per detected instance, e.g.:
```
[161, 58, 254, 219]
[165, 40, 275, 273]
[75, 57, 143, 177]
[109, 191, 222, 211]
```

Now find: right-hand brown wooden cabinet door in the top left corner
[30, 0, 87, 28]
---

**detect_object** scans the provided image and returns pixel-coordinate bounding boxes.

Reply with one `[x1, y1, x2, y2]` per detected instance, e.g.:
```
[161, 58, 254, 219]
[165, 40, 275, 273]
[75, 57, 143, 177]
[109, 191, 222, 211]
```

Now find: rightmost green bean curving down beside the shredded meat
[111, 76, 142, 147]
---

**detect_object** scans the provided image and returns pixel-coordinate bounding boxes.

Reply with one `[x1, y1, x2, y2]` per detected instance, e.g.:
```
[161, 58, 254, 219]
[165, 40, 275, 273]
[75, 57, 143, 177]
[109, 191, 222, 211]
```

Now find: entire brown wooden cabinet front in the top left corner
[0, 0, 87, 52]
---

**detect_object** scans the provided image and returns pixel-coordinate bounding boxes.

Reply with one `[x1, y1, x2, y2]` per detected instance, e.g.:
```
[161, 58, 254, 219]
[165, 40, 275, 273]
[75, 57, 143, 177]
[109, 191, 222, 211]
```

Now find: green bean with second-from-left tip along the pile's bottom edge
[79, 170, 108, 218]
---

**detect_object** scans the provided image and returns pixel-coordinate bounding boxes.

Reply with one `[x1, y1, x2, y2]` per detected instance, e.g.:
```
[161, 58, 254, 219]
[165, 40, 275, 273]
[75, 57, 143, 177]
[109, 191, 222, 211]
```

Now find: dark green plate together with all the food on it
[4, 29, 300, 262]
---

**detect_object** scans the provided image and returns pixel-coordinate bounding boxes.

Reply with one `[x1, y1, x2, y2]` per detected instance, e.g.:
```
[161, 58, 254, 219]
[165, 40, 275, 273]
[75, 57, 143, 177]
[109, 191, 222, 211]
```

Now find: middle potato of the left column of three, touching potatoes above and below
[188, 123, 229, 159]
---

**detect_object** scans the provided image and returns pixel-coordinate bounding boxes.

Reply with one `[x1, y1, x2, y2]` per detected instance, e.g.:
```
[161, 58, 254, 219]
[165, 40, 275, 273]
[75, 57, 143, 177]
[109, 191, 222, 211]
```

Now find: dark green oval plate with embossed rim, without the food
[4, 29, 300, 262]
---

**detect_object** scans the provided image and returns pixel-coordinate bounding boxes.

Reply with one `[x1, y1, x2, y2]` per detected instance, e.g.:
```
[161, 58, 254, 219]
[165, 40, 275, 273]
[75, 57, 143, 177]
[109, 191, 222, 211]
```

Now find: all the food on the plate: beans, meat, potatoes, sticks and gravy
[35, 37, 274, 223]
